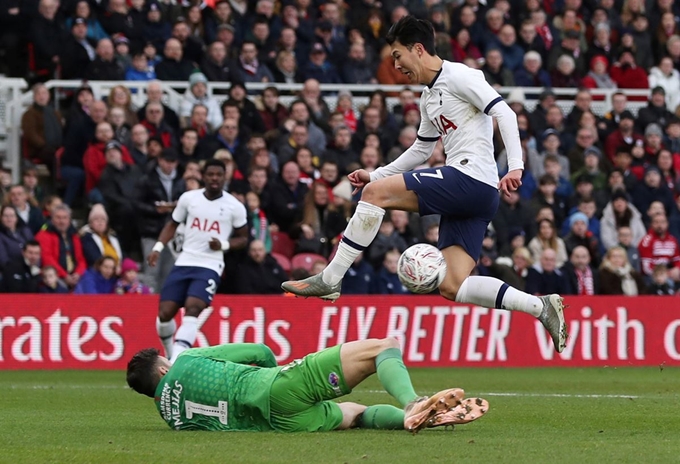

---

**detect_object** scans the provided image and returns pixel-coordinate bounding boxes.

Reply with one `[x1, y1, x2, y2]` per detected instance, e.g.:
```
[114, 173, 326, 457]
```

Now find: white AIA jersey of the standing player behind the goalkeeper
[172, 189, 248, 275]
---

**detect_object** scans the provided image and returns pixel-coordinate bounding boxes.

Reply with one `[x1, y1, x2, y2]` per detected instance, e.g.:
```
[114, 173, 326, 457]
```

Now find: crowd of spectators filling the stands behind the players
[0, 0, 680, 295]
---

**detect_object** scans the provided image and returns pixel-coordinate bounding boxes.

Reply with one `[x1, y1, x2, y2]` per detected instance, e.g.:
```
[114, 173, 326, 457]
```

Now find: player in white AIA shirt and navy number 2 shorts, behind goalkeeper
[147, 160, 248, 362]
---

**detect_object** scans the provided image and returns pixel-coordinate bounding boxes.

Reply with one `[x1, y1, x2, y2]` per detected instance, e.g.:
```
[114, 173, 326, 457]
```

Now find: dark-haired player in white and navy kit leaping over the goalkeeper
[282, 16, 567, 352]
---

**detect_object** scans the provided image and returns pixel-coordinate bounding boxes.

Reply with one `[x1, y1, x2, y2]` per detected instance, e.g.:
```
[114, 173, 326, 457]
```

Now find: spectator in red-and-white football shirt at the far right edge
[638, 213, 680, 282]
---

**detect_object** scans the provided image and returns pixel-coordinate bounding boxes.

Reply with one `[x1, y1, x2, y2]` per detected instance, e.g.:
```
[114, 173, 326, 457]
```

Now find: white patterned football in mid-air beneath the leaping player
[397, 243, 446, 293]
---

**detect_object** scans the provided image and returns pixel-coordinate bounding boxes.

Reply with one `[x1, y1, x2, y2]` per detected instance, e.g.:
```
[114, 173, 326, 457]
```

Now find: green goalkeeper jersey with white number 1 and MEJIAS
[155, 343, 280, 431]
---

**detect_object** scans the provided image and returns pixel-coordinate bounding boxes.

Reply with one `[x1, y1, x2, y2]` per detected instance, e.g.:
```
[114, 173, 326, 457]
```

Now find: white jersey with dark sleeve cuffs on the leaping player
[418, 61, 503, 188]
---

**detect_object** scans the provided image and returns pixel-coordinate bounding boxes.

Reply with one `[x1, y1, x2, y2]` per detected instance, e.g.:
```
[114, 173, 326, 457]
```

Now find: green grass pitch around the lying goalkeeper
[0, 368, 680, 464]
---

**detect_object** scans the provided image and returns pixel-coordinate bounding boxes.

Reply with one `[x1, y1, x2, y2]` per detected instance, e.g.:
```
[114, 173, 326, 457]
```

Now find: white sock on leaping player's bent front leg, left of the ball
[321, 201, 385, 285]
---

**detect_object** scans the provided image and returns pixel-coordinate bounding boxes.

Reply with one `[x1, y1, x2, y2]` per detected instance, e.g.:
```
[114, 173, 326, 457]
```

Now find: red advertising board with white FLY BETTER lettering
[0, 295, 680, 370]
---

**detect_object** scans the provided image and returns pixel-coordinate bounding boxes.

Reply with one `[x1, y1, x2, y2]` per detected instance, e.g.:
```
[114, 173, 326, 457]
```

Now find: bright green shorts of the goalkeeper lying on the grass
[269, 346, 351, 432]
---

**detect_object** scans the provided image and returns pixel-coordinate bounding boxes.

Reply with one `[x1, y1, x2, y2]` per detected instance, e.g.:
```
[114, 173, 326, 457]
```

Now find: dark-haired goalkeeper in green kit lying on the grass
[127, 338, 489, 433]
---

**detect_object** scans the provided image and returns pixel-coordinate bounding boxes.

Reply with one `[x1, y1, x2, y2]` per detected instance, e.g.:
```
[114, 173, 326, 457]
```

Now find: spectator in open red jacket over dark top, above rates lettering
[35, 205, 87, 288]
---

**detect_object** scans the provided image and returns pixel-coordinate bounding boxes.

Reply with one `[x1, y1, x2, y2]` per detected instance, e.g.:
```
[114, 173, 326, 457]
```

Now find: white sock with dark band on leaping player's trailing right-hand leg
[456, 276, 543, 317]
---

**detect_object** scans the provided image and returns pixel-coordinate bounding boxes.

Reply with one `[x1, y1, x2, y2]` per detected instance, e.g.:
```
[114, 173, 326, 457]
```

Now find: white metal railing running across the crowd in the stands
[0, 79, 650, 182]
